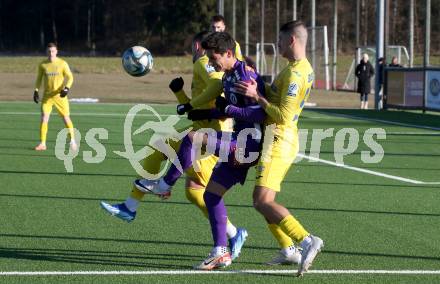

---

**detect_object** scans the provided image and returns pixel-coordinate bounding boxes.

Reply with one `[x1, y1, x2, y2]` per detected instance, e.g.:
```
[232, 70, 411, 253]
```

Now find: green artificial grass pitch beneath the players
[0, 102, 440, 283]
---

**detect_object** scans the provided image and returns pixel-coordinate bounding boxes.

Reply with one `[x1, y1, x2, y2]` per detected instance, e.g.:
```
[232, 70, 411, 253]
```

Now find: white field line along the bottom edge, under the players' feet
[0, 269, 440, 276]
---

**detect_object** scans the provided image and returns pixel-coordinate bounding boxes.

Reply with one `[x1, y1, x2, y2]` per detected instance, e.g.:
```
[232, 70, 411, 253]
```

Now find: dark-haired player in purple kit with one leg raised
[135, 32, 265, 270]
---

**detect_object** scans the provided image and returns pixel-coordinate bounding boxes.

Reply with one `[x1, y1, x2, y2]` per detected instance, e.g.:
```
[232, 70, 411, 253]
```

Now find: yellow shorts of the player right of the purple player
[255, 134, 299, 192]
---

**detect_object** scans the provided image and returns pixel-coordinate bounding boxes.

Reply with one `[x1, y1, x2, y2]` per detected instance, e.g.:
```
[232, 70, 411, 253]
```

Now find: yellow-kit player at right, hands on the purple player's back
[236, 21, 324, 276]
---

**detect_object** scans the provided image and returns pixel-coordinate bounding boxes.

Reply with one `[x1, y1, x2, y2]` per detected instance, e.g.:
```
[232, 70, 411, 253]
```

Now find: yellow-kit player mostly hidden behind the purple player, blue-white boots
[101, 32, 247, 259]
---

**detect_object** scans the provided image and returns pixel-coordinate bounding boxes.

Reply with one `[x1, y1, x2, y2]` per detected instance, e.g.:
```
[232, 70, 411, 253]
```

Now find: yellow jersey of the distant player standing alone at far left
[35, 58, 73, 96]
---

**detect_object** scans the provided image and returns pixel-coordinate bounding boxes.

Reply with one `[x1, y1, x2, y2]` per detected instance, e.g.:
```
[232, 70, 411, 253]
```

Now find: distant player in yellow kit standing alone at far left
[34, 43, 77, 151]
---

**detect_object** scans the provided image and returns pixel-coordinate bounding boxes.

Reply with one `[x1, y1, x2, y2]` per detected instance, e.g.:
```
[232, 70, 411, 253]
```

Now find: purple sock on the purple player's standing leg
[203, 191, 228, 247]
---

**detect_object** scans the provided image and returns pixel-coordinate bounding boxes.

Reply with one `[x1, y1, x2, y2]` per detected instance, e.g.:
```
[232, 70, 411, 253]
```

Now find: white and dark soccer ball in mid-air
[122, 46, 153, 77]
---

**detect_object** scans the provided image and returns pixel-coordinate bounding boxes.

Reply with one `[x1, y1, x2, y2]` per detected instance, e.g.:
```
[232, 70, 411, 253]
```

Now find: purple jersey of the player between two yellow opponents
[223, 60, 266, 133]
